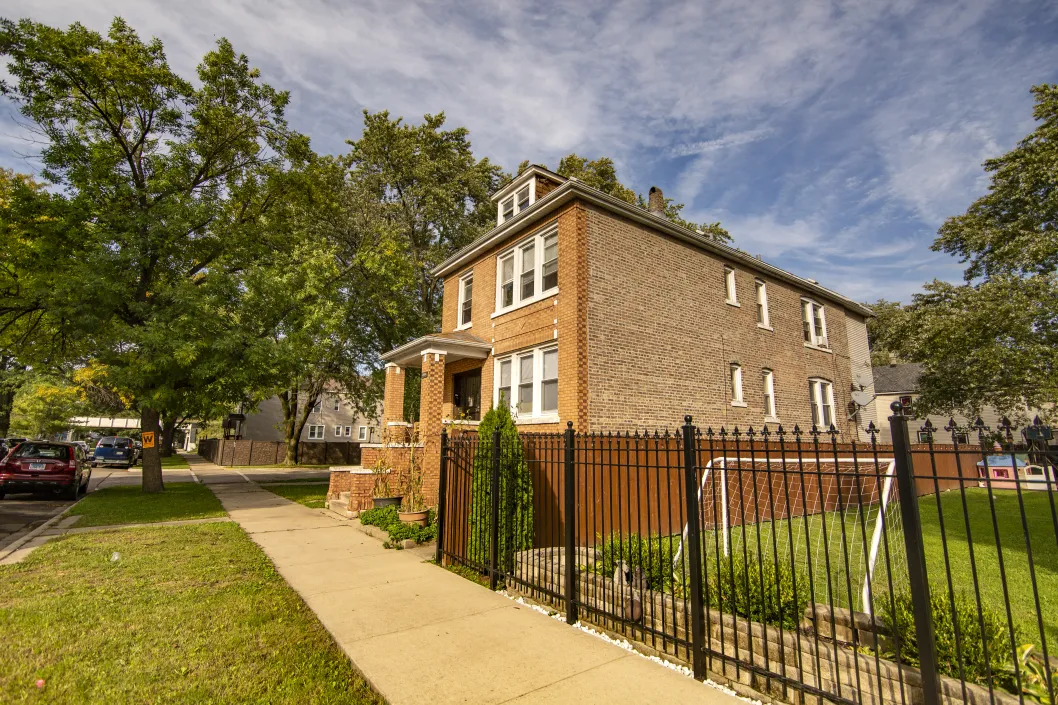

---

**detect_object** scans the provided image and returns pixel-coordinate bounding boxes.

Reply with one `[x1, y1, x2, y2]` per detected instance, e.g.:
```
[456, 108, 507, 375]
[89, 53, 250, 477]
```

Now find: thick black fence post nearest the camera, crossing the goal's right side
[889, 401, 941, 705]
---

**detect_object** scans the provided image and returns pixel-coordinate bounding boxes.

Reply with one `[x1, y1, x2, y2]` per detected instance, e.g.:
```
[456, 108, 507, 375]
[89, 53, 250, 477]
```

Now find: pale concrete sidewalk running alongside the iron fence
[188, 456, 741, 705]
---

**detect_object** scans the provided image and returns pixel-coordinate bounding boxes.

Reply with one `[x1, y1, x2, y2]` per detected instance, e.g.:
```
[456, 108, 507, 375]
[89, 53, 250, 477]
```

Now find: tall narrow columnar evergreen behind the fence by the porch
[467, 404, 533, 565]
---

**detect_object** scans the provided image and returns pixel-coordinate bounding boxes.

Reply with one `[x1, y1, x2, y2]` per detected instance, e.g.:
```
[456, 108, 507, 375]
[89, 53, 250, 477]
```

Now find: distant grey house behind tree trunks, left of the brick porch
[240, 391, 380, 442]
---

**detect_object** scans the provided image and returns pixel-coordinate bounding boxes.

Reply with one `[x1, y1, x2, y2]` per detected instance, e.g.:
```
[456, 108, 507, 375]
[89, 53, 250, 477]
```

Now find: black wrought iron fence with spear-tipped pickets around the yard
[437, 410, 1058, 705]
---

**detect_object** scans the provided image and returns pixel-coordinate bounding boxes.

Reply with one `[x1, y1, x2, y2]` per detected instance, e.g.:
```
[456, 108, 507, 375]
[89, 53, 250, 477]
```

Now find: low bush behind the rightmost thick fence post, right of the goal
[879, 586, 1018, 685]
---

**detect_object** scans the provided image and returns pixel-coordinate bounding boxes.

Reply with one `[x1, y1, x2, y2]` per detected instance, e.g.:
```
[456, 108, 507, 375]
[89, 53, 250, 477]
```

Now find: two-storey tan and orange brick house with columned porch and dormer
[364, 166, 874, 499]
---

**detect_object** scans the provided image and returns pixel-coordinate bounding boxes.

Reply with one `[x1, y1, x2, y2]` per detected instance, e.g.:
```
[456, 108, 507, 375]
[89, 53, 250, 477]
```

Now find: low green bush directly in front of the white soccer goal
[706, 556, 809, 629]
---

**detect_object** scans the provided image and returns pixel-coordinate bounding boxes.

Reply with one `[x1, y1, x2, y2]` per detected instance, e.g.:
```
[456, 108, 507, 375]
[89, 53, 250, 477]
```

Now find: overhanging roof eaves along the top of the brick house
[433, 176, 874, 317]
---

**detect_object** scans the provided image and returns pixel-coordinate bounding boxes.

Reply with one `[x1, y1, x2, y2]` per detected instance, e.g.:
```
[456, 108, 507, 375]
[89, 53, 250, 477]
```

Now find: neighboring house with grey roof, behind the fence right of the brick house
[874, 362, 1038, 444]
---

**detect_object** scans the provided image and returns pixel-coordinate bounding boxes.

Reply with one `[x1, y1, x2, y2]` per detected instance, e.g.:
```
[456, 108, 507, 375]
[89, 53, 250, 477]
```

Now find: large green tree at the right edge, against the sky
[892, 85, 1058, 420]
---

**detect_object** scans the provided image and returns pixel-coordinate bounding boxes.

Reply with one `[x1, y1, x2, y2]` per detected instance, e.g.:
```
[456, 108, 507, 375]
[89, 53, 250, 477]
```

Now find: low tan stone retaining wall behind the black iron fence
[508, 548, 1019, 705]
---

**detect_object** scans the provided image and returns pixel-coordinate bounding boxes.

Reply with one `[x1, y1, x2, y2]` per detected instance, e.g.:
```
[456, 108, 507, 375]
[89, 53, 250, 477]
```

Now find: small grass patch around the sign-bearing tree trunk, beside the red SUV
[67, 483, 224, 527]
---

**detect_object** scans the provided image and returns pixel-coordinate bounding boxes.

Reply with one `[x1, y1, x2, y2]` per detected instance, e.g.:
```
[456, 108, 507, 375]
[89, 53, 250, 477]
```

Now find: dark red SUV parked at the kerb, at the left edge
[0, 440, 92, 500]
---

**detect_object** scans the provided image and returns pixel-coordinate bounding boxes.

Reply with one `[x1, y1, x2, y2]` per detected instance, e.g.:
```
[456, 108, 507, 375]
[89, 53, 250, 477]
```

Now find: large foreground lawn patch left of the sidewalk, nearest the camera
[0, 524, 383, 704]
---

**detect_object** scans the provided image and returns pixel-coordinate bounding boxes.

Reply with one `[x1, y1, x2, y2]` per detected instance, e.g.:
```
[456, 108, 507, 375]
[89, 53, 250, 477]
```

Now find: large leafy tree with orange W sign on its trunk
[0, 19, 308, 491]
